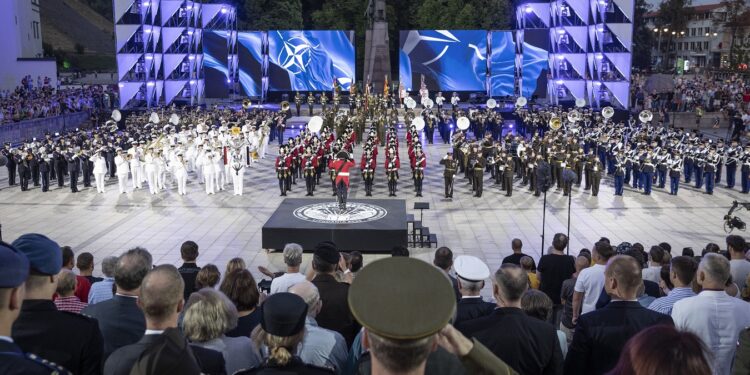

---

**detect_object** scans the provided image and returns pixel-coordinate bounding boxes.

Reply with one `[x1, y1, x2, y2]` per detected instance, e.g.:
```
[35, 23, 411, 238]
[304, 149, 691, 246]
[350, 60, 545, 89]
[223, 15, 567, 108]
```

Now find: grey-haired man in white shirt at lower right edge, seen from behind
[672, 253, 750, 375]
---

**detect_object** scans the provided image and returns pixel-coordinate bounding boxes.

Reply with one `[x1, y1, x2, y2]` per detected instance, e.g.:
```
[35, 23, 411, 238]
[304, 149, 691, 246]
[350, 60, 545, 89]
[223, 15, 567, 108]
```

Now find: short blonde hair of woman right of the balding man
[182, 288, 237, 342]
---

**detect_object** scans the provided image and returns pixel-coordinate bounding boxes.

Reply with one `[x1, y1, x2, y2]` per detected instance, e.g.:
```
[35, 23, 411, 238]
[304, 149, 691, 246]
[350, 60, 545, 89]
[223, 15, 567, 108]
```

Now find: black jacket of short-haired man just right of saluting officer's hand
[456, 307, 563, 375]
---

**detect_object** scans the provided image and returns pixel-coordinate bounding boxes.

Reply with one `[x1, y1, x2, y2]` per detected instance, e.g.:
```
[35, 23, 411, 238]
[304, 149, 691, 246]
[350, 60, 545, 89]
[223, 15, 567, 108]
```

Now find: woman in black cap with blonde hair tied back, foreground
[235, 292, 334, 375]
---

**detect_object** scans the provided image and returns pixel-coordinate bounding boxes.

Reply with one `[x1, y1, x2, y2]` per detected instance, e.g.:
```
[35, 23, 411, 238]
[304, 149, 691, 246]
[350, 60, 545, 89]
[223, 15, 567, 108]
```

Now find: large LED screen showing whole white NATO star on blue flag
[268, 30, 355, 91]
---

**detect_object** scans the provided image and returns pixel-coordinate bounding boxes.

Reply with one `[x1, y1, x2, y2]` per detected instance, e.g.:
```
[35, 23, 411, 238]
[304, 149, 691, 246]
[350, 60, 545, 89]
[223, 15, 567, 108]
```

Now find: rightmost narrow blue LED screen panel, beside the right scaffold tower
[521, 29, 550, 98]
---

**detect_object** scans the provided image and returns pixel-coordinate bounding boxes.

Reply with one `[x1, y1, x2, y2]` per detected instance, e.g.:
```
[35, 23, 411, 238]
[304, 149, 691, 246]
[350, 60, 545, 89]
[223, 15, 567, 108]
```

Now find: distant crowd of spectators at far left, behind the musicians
[0, 76, 119, 124]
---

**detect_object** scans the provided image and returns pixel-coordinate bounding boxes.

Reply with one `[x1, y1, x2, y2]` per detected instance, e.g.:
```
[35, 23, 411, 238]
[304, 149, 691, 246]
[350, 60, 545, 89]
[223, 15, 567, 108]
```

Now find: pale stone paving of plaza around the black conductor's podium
[0, 131, 750, 292]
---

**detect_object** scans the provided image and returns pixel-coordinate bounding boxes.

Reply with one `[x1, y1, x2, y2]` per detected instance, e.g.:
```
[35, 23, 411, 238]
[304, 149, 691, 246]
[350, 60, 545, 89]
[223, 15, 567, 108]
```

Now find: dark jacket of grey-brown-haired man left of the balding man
[81, 294, 146, 360]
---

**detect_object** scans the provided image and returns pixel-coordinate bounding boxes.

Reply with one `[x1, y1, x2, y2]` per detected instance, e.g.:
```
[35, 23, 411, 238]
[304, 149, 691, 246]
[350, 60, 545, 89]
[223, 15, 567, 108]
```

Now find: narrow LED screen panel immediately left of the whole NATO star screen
[237, 31, 264, 96]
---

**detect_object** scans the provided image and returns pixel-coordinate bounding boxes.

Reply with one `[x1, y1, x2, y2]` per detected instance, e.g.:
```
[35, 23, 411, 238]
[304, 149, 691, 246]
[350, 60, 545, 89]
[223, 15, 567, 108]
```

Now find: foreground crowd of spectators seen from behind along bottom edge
[0, 233, 750, 375]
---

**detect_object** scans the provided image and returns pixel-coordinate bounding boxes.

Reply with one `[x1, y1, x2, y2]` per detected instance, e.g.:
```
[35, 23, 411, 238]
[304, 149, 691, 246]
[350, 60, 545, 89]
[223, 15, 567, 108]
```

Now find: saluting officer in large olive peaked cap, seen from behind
[349, 257, 525, 374]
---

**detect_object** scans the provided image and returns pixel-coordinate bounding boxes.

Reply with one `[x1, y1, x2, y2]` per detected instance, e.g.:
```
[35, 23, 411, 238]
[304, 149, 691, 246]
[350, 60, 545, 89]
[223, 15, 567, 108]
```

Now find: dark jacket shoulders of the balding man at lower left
[104, 335, 226, 375]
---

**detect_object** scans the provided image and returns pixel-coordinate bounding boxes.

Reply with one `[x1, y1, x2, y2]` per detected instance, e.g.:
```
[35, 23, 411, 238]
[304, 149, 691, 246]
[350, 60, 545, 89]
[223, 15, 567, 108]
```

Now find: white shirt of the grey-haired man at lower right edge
[672, 290, 750, 375]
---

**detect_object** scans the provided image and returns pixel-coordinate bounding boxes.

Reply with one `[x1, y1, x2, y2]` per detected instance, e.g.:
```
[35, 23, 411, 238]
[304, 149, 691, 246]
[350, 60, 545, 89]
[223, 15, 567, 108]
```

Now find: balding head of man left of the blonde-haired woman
[138, 265, 185, 322]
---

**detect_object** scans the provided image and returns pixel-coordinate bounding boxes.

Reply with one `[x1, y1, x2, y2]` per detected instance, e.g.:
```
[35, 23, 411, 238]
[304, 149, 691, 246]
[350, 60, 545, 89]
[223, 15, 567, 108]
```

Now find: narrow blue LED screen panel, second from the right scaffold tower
[490, 31, 516, 96]
